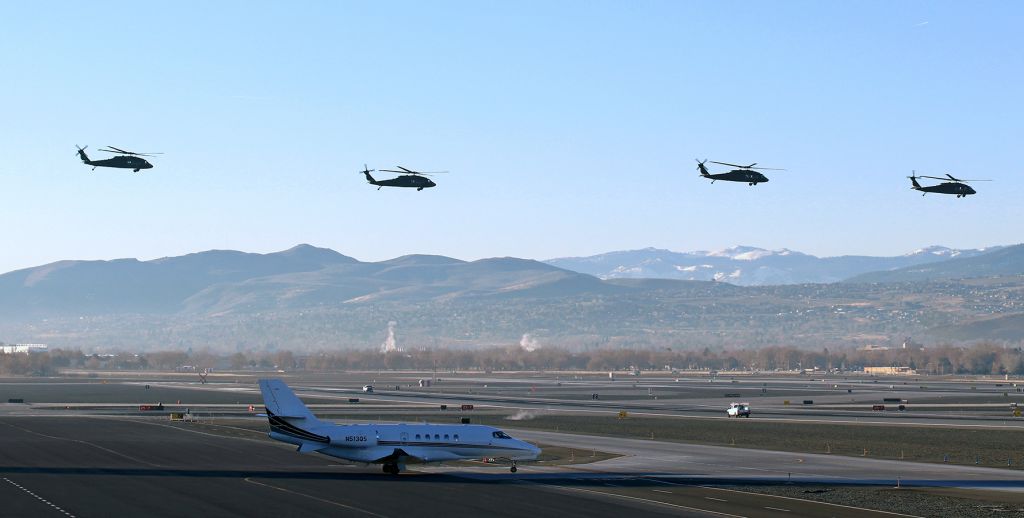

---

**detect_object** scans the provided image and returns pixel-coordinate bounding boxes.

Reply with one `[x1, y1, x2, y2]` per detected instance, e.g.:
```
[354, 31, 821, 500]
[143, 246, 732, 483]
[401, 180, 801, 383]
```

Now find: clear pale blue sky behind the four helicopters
[0, 0, 1024, 271]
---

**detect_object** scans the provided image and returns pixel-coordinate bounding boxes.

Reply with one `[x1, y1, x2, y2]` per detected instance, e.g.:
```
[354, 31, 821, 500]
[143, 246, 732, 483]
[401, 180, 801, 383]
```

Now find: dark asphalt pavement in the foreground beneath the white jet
[0, 416, 942, 518]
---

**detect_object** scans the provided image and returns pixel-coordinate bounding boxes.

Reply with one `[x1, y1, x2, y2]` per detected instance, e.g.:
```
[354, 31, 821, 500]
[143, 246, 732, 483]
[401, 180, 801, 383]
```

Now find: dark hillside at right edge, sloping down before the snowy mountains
[849, 245, 1024, 283]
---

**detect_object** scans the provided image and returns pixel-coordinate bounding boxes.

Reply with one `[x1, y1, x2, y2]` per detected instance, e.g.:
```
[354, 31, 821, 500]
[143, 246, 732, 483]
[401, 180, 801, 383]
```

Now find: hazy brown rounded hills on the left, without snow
[0, 245, 625, 318]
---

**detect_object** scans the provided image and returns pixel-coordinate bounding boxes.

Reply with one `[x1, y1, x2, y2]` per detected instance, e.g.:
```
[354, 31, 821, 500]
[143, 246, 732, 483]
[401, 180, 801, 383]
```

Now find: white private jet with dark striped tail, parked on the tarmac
[259, 380, 541, 475]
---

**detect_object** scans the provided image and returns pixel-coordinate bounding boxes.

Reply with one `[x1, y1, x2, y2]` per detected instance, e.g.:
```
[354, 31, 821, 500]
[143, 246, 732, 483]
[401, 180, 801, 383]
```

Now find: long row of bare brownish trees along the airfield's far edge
[0, 342, 1024, 376]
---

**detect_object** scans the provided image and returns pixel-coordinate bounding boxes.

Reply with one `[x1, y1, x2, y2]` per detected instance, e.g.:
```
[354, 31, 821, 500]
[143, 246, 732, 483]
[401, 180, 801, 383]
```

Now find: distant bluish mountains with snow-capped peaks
[546, 247, 995, 286]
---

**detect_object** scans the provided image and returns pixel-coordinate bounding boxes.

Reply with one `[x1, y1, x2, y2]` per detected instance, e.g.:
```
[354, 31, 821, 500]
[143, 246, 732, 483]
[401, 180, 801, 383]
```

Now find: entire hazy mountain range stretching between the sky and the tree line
[0, 245, 1024, 350]
